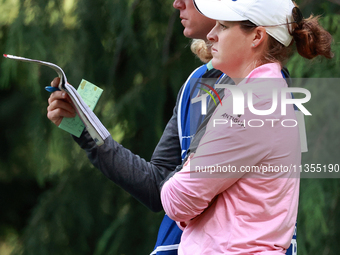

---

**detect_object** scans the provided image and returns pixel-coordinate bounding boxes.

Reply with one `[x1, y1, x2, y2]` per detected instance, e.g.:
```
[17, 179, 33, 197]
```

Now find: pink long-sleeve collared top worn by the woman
[161, 63, 301, 255]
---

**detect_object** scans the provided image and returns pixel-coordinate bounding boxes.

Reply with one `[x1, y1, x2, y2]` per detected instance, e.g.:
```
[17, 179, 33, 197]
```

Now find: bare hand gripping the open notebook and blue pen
[47, 77, 76, 126]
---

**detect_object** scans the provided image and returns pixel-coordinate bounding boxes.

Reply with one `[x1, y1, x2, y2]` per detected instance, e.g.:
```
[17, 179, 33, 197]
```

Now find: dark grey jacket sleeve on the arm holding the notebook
[74, 87, 183, 212]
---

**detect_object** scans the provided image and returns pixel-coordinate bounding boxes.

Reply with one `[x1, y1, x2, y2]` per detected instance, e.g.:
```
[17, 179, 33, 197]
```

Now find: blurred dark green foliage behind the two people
[0, 0, 340, 255]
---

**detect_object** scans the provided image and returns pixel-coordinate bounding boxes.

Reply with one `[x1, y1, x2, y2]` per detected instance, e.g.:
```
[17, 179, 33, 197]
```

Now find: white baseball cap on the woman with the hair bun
[194, 0, 295, 46]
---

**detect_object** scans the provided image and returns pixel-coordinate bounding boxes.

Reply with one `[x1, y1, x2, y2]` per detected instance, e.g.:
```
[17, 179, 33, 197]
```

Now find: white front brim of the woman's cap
[193, 0, 247, 21]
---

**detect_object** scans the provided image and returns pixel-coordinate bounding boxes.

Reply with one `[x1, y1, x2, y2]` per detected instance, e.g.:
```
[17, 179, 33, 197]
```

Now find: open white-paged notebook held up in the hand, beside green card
[3, 54, 110, 146]
